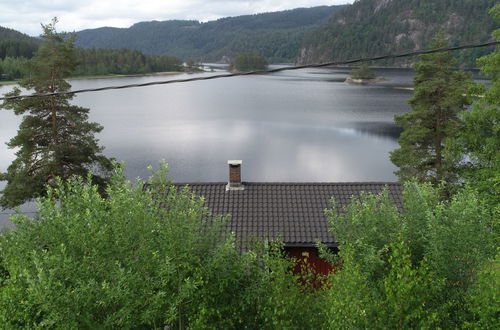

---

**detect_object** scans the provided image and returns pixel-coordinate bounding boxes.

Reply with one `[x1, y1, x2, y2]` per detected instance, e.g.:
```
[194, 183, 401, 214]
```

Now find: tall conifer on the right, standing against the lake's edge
[391, 33, 472, 189]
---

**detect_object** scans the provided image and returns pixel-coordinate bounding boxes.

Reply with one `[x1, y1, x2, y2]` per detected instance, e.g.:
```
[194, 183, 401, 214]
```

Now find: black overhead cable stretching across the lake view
[0, 41, 500, 100]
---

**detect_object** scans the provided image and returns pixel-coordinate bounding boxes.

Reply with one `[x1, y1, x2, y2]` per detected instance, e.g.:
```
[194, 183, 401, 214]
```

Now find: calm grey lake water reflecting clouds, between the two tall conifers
[0, 65, 413, 226]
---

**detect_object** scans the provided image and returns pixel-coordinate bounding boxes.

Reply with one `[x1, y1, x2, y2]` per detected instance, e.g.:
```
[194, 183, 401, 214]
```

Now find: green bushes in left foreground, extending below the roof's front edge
[0, 164, 332, 329]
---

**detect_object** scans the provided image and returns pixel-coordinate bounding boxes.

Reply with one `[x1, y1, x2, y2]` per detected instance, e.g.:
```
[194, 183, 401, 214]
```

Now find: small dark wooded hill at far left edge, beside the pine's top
[0, 26, 40, 59]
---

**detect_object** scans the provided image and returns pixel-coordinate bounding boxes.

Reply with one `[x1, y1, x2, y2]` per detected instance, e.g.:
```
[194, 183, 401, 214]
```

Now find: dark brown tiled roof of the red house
[176, 182, 402, 246]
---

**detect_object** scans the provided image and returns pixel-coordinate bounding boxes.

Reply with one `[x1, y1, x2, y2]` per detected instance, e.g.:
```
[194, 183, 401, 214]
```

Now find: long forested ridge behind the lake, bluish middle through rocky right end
[72, 0, 498, 67]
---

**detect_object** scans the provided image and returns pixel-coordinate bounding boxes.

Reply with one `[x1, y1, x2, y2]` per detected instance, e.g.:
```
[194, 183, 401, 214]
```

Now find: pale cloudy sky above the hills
[0, 0, 354, 36]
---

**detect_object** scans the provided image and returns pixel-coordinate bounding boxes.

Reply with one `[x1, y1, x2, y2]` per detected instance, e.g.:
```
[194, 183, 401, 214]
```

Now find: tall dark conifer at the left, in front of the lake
[0, 19, 111, 208]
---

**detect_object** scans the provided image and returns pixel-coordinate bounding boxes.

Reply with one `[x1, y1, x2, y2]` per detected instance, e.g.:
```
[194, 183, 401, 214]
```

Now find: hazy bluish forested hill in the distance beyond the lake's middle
[76, 6, 344, 62]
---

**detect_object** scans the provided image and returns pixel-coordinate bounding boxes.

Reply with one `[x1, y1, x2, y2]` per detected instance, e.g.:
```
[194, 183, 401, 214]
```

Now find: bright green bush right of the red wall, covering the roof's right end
[328, 183, 498, 328]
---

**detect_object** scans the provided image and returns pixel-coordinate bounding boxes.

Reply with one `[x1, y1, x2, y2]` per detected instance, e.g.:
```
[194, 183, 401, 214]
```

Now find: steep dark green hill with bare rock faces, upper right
[298, 0, 498, 66]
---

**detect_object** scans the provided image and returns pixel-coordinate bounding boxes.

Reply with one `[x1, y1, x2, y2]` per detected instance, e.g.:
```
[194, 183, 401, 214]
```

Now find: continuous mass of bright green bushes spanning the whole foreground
[0, 173, 499, 329]
